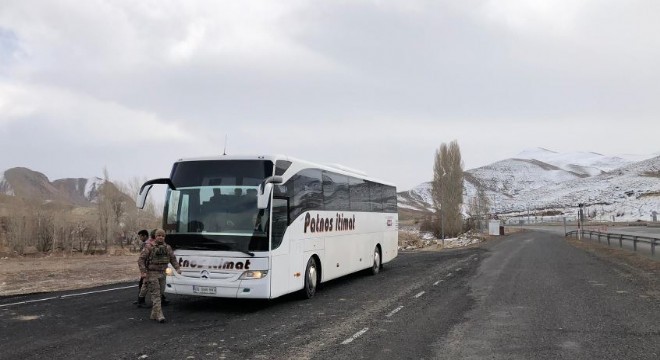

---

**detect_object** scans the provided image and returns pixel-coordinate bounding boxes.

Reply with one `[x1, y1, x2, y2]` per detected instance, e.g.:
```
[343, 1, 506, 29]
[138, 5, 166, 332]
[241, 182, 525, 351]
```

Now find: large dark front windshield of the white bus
[165, 161, 272, 252]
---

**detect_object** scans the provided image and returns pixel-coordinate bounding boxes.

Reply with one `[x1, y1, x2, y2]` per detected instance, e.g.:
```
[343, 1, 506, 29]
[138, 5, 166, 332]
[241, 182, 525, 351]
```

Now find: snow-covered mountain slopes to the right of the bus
[398, 148, 660, 221]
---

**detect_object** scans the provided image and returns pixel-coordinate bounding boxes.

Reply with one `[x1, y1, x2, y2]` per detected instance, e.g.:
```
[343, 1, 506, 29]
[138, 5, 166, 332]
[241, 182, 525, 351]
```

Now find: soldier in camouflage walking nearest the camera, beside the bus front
[138, 229, 181, 323]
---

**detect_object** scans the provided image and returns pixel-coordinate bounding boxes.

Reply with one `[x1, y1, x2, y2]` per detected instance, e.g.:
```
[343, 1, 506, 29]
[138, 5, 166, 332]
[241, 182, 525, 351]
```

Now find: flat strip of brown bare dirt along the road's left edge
[0, 254, 140, 296]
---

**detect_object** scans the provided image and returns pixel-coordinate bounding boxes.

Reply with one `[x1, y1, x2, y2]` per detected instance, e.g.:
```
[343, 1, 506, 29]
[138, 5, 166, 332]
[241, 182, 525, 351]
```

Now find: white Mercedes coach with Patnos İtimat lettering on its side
[137, 155, 398, 299]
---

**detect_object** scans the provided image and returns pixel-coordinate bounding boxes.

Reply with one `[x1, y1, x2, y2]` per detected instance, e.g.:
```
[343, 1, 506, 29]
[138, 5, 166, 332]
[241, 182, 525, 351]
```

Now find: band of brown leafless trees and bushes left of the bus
[0, 169, 161, 254]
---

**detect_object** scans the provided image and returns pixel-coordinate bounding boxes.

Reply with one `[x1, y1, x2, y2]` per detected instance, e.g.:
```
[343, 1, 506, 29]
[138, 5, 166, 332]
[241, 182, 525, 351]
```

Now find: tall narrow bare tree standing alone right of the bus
[431, 140, 463, 238]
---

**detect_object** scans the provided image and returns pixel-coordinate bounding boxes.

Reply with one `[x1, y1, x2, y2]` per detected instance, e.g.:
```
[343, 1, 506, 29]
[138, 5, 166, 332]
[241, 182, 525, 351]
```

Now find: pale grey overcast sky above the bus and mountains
[0, 0, 660, 190]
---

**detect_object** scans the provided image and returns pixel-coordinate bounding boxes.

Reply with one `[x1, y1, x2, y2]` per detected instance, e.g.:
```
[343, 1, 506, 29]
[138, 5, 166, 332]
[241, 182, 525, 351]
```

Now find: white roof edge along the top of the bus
[176, 154, 395, 186]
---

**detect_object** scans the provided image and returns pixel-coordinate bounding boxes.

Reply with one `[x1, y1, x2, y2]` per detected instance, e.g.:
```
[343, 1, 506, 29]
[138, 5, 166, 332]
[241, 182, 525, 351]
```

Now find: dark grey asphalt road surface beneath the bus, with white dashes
[0, 231, 660, 359]
